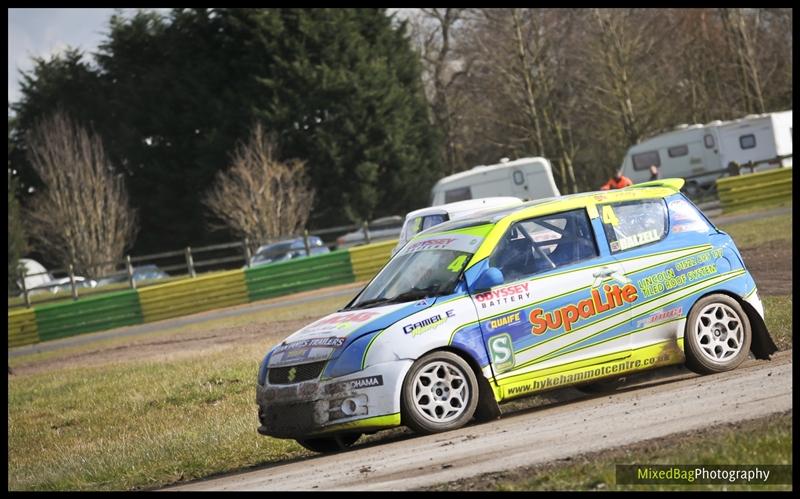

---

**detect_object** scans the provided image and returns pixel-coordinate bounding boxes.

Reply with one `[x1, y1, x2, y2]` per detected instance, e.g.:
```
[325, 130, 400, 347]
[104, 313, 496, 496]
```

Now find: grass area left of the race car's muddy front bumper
[8, 347, 307, 490]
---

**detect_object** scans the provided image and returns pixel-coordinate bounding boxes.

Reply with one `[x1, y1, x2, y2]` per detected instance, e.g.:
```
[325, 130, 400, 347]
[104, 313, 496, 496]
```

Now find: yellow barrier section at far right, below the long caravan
[717, 166, 792, 211]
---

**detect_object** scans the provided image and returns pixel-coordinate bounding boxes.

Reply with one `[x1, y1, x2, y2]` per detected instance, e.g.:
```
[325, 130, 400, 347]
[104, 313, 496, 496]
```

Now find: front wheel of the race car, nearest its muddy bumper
[400, 352, 478, 433]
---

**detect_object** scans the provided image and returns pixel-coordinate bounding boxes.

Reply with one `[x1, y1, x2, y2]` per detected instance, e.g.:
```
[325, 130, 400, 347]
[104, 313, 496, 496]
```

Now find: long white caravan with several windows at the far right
[622, 110, 792, 192]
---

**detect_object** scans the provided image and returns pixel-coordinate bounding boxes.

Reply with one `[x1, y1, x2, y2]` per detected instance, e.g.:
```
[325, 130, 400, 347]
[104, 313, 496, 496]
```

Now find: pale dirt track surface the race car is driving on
[166, 350, 792, 490]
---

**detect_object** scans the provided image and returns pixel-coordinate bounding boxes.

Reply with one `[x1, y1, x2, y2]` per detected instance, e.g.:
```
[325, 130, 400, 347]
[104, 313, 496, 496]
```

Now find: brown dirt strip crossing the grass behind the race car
[13, 241, 792, 374]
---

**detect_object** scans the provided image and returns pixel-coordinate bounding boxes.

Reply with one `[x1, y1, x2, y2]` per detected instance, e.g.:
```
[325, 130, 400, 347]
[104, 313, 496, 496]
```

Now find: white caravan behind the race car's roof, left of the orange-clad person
[431, 157, 559, 206]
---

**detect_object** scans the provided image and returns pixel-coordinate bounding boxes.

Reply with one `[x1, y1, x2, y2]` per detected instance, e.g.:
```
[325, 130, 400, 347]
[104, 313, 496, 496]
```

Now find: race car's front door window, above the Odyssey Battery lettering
[489, 209, 599, 282]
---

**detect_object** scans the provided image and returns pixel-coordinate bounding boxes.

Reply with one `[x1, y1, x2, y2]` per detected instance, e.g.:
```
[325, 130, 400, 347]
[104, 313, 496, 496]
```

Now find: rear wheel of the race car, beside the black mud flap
[684, 294, 753, 374]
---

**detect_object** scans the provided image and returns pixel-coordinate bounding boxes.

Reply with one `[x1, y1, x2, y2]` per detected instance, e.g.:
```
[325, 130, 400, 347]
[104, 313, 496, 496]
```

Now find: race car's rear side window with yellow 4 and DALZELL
[598, 199, 667, 253]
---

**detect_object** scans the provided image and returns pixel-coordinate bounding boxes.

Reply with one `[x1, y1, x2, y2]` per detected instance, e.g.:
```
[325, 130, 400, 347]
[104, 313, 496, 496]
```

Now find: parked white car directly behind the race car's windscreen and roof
[392, 196, 522, 255]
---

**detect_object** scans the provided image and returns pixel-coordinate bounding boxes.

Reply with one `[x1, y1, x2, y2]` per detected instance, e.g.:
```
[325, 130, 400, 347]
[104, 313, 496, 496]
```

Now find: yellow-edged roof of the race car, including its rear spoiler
[415, 178, 684, 239]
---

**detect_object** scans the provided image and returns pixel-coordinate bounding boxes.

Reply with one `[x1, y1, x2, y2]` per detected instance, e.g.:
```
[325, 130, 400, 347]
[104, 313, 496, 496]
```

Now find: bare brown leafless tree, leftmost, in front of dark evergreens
[27, 112, 137, 276]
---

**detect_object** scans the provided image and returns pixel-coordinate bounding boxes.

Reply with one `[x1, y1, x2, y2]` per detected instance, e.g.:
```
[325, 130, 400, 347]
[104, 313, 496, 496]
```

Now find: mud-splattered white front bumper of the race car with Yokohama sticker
[256, 360, 412, 438]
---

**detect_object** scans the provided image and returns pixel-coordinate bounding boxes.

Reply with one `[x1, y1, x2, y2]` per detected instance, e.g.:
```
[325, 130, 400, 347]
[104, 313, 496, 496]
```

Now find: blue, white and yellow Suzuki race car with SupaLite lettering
[256, 179, 777, 451]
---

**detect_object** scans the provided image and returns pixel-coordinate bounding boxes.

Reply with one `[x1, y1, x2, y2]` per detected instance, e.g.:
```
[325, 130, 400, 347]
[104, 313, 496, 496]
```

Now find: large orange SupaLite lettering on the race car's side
[529, 284, 639, 335]
